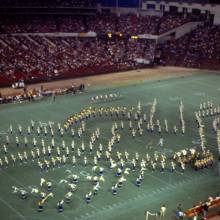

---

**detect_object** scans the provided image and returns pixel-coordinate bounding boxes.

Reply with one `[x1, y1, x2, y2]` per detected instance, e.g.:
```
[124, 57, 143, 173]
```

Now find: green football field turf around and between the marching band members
[0, 72, 220, 220]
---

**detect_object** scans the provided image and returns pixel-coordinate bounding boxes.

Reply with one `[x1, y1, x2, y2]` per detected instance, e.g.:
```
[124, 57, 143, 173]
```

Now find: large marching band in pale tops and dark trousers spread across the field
[0, 99, 220, 212]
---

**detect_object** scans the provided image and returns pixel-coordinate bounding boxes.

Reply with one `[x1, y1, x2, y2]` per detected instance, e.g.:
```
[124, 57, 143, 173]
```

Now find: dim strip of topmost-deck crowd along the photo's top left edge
[0, 0, 97, 8]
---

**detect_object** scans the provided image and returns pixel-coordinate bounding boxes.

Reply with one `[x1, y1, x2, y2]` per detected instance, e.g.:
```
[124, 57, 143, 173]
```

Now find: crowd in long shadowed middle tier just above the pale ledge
[0, 13, 203, 35]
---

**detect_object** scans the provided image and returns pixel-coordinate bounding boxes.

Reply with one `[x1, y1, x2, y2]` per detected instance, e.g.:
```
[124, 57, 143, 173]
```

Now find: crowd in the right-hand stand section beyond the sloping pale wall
[159, 23, 220, 69]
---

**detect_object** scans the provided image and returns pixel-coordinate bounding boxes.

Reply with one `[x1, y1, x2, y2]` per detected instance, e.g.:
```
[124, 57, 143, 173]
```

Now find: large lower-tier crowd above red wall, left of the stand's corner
[0, 35, 154, 84]
